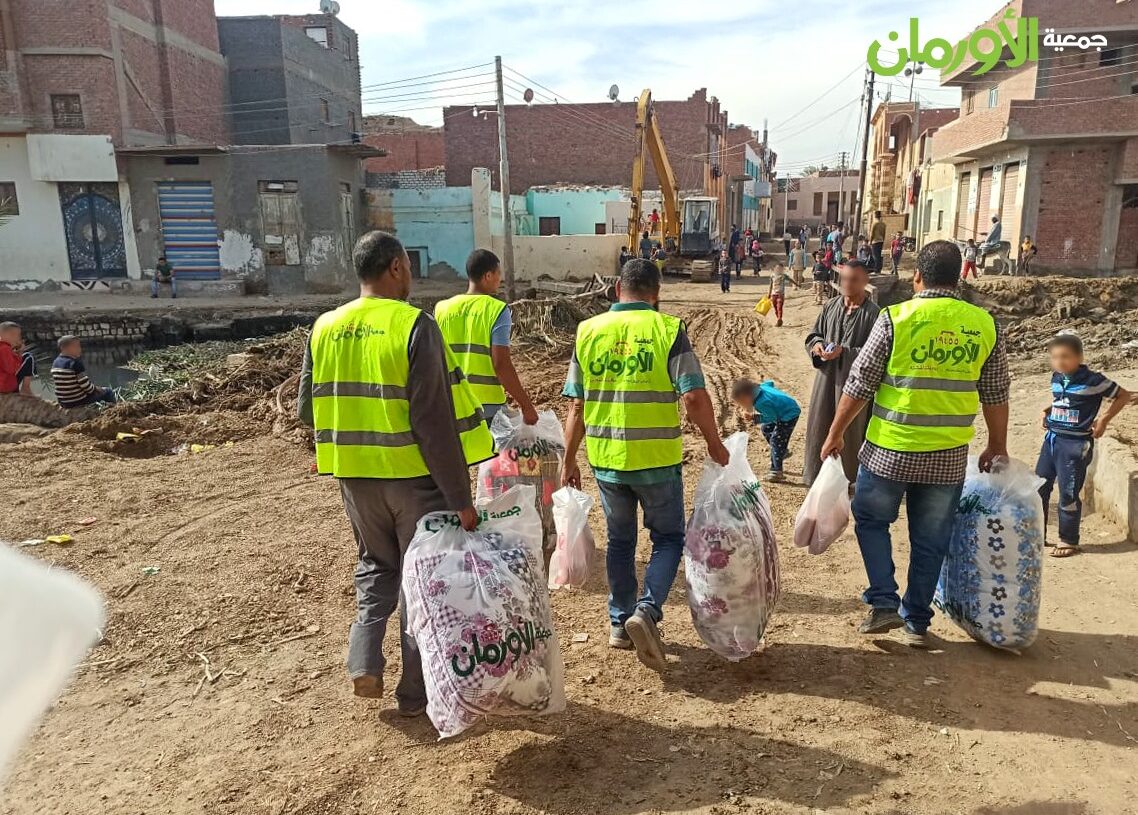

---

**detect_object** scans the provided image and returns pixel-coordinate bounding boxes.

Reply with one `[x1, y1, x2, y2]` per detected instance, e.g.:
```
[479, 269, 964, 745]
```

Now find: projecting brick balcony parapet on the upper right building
[933, 94, 1138, 164]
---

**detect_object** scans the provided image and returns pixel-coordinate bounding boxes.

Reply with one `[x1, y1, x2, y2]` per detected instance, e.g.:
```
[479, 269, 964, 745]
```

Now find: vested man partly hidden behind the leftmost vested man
[435, 249, 537, 425]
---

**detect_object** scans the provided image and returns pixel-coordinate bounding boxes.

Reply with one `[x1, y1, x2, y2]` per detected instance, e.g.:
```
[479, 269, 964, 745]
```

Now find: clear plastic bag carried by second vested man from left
[478, 408, 566, 553]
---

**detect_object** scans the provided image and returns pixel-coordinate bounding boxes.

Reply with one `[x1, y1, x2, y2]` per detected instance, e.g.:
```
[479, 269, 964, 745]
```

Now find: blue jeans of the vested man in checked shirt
[854, 467, 964, 633]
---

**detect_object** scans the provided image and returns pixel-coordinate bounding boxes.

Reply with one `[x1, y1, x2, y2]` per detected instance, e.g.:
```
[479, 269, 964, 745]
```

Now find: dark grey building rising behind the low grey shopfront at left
[217, 14, 361, 145]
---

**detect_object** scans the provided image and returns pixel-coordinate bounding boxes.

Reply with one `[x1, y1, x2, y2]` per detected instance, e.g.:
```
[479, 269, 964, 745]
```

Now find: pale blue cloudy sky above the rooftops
[215, 0, 1000, 174]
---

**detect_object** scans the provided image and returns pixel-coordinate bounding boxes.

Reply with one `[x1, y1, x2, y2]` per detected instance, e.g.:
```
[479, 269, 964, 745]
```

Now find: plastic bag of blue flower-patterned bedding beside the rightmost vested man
[933, 456, 1044, 651]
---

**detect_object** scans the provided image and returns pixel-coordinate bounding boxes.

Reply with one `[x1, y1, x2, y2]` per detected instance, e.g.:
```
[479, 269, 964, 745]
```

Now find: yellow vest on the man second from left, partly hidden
[435, 295, 505, 405]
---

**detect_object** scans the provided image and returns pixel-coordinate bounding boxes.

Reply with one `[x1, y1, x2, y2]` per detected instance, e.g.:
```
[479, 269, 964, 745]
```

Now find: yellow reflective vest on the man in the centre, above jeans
[577, 308, 684, 471]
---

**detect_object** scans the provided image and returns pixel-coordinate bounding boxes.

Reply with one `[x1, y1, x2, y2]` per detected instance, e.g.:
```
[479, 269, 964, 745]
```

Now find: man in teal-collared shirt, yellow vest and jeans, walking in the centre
[563, 258, 728, 670]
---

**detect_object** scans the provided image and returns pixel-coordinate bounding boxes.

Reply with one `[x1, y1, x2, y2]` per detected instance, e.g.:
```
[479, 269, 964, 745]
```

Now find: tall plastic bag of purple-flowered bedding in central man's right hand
[684, 433, 780, 661]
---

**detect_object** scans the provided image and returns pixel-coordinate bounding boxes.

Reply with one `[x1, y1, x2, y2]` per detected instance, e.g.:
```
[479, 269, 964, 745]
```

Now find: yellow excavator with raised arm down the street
[628, 88, 723, 277]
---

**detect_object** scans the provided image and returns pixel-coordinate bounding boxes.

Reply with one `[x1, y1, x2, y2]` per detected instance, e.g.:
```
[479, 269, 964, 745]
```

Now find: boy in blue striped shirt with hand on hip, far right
[1036, 334, 1133, 558]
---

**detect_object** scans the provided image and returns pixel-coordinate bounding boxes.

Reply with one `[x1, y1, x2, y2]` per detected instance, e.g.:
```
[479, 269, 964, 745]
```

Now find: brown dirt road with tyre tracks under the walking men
[0, 280, 1138, 815]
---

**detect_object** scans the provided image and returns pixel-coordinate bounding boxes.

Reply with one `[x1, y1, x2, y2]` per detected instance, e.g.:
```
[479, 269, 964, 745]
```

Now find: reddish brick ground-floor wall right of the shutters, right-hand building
[1031, 145, 1116, 269]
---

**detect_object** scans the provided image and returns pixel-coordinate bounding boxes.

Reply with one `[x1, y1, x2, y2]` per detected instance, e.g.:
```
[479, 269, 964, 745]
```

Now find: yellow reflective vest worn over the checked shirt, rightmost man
[866, 297, 996, 453]
